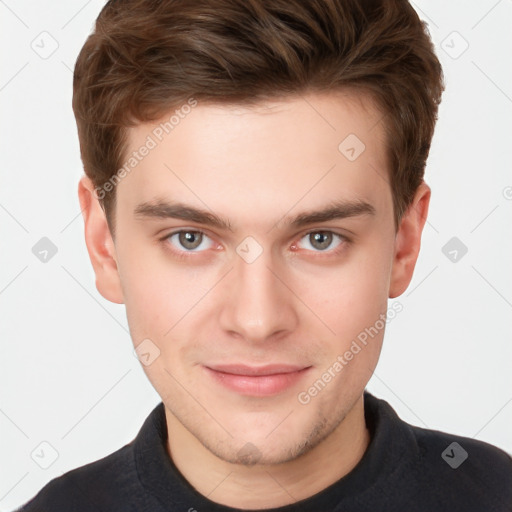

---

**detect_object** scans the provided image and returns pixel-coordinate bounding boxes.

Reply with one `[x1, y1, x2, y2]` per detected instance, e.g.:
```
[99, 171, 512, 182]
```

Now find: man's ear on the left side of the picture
[78, 176, 124, 304]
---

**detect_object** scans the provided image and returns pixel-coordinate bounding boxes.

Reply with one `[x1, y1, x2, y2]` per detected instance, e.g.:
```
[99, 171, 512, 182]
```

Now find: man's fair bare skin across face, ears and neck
[79, 91, 430, 509]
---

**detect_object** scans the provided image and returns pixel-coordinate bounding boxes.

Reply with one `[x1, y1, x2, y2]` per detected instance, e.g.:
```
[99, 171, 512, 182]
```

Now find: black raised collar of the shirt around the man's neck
[134, 390, 419, 512]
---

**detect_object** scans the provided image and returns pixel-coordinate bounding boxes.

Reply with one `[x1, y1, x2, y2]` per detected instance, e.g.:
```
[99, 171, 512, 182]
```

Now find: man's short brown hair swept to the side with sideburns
[73, 0, 444, 233]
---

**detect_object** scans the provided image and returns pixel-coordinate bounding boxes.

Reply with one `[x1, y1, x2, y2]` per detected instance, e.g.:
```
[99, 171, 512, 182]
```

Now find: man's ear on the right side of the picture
[389, 181, 430, 299]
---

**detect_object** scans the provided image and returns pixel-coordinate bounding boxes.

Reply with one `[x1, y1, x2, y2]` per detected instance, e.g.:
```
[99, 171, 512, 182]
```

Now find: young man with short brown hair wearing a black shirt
[16, 0, 512, 512]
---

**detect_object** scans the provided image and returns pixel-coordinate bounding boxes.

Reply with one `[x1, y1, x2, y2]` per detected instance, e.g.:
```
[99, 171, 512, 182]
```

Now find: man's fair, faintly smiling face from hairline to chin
[79, 92, 428, 463]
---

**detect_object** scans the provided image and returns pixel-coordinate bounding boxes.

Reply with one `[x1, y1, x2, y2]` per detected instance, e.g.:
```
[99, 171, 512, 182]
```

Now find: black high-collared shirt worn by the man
[19, 391, 512, 512]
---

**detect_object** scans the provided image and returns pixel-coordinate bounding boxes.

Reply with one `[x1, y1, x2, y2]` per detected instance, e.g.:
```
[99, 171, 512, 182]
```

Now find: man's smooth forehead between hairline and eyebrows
[117, 91, 391, 230]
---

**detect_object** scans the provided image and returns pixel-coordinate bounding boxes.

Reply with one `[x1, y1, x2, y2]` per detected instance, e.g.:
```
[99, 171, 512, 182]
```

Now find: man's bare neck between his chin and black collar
[166, 396, 370, 509]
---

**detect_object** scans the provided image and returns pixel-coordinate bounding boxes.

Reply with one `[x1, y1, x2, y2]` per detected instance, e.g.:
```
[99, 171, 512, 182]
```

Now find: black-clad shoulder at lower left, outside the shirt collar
[15, 443, 138, 512]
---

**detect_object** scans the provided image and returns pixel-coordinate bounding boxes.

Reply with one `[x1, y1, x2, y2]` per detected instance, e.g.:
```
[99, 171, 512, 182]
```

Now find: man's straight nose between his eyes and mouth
[220, 243, 298, 343]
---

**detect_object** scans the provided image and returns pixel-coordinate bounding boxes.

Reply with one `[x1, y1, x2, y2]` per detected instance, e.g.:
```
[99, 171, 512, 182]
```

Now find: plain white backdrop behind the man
[0, 0, 512, 511]
